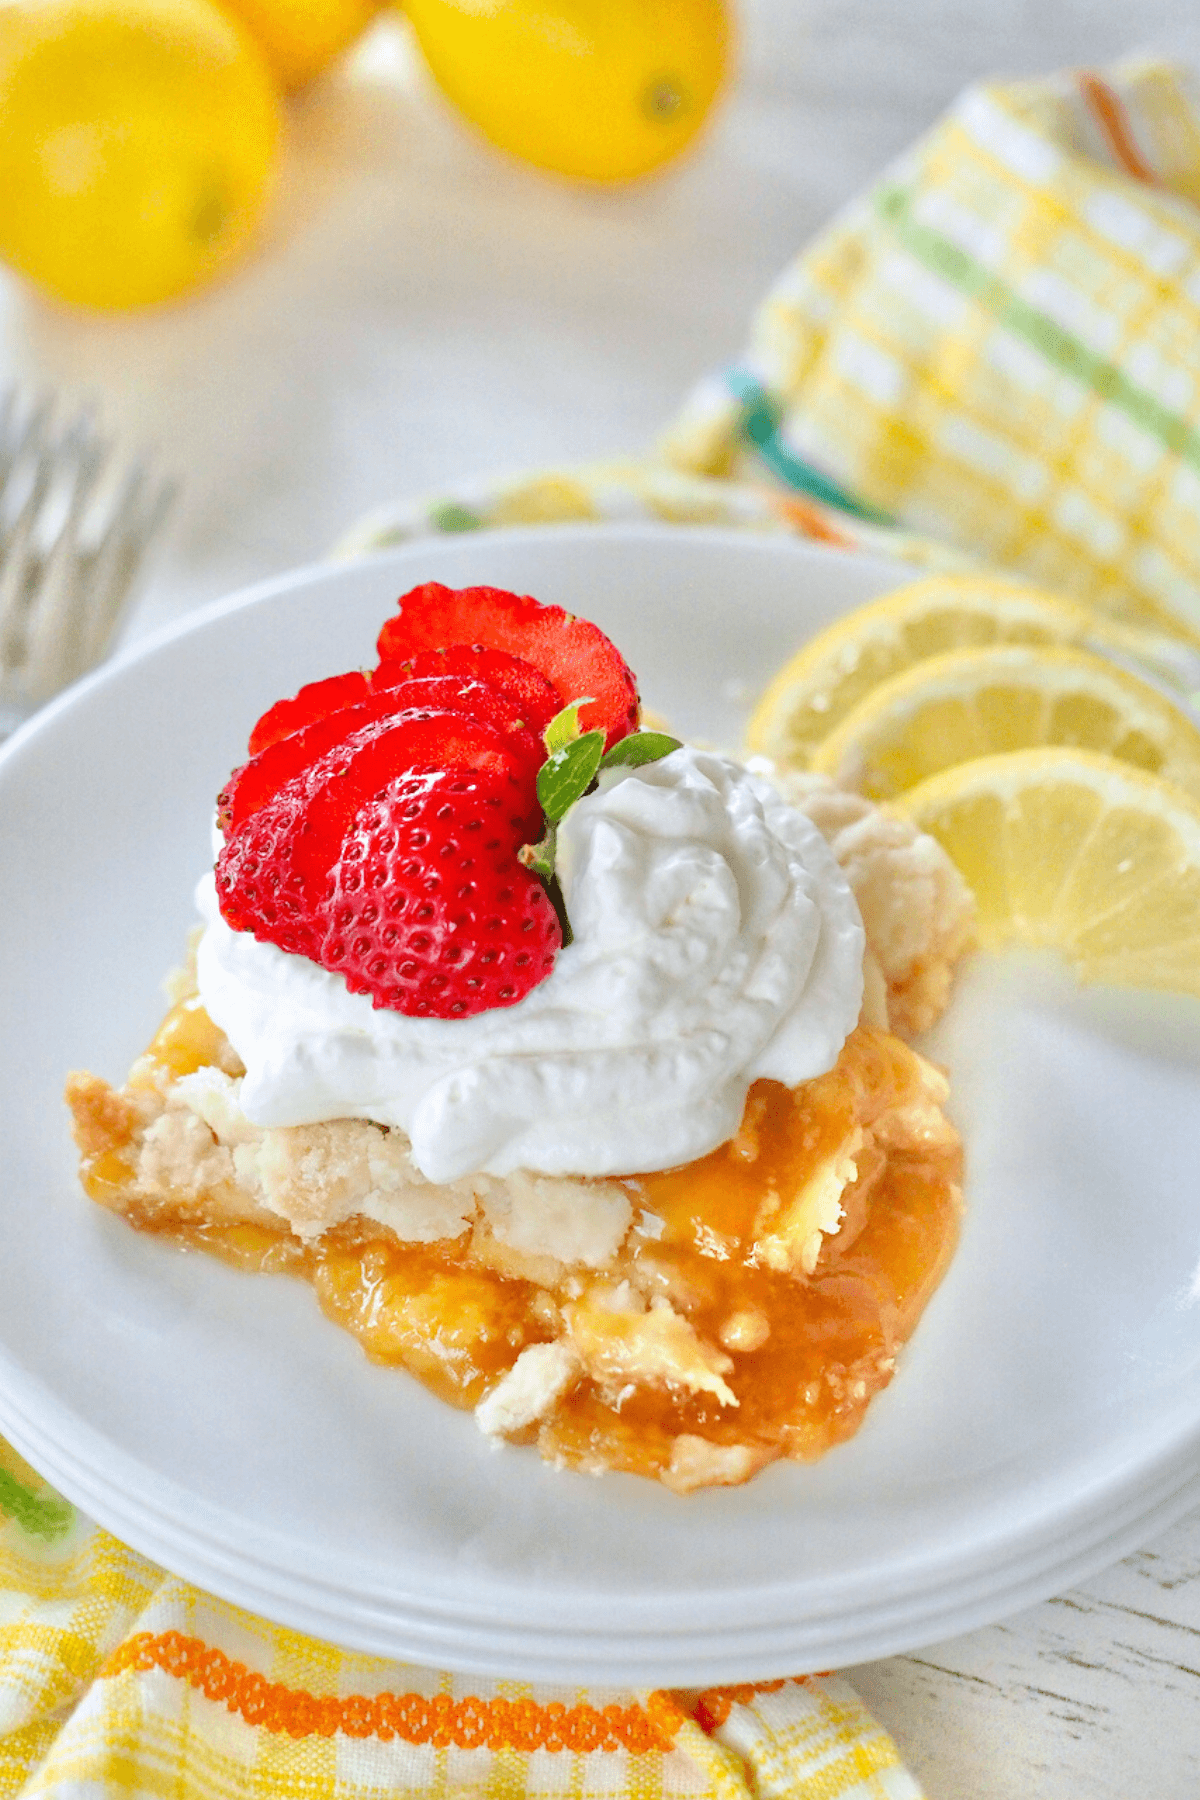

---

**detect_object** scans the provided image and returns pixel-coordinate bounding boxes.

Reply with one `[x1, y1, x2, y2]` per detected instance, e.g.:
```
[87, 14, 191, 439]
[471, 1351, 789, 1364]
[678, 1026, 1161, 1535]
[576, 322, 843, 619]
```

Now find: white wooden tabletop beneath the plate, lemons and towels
[0, 10, 1200, 1800]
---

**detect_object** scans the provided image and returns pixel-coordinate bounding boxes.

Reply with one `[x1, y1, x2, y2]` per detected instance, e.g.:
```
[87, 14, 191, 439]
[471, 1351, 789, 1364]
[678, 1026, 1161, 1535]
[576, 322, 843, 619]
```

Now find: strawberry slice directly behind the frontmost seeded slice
[216, 711, 542, 956]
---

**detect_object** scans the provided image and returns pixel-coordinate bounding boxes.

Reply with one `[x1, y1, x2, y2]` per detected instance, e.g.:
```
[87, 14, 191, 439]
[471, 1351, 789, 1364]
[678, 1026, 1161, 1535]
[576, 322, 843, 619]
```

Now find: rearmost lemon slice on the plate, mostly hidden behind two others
[747, 576, 1200, 769]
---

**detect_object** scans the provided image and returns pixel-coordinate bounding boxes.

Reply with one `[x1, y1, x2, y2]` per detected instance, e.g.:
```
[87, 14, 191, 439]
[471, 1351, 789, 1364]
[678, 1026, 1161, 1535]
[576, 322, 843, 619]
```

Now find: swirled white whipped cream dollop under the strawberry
[198, 747, 864, 1181]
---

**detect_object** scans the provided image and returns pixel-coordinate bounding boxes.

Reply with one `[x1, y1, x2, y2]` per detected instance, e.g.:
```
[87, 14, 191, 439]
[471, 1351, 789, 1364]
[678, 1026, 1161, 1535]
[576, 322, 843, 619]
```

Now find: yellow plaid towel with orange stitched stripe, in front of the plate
[0, 1440, 921, 1800]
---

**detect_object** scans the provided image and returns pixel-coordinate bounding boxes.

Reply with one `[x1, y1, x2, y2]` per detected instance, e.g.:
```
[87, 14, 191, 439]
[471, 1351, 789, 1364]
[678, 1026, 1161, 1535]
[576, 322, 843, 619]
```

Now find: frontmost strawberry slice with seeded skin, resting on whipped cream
[320, 769, 563, 1019]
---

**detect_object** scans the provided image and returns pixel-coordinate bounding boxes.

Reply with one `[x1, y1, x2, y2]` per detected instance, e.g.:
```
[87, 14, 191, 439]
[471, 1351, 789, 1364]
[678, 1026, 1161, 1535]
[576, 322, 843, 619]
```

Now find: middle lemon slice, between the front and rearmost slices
[810, 644, 1200, 799]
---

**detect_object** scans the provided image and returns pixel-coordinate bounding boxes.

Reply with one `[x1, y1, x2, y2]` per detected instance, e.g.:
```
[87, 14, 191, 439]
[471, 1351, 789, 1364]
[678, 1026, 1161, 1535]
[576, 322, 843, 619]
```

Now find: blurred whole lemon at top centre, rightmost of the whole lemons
[405, 0, 732, 182]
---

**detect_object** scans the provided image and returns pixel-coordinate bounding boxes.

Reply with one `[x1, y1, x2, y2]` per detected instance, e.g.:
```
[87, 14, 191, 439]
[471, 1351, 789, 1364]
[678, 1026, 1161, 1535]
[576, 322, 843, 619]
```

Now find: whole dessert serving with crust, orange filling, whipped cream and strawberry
[67, 587, 972, 1490]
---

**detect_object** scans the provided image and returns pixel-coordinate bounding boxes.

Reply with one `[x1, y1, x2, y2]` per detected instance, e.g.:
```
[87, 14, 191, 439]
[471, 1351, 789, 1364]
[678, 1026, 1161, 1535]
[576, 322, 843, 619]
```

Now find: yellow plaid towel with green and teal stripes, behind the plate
[340, 59, 1200, 662]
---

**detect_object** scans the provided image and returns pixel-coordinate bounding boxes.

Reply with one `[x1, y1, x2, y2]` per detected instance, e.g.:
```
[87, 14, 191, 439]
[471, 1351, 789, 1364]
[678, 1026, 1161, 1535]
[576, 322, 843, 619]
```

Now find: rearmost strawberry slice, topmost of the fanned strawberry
[378, 581, 637, 749]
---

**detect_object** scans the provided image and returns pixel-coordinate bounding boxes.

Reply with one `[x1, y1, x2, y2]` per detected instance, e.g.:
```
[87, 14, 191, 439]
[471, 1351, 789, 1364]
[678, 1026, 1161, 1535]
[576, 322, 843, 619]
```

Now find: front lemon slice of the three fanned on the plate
[898, 747, 1200, 995]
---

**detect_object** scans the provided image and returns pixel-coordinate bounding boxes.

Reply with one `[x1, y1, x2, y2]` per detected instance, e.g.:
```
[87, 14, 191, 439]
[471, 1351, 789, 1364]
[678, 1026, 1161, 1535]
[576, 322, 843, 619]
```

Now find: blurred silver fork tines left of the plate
[0, 389, 176, 738]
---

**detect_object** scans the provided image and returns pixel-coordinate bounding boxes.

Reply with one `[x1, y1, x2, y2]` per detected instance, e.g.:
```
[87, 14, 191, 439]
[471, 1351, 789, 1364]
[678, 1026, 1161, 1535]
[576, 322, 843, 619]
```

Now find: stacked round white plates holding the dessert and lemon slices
[0, 527, 1200, 1685]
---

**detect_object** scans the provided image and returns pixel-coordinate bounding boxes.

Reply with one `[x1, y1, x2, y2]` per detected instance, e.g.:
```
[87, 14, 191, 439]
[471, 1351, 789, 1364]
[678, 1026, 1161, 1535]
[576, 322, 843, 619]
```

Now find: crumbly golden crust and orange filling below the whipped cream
[67, 778, 972, 1492]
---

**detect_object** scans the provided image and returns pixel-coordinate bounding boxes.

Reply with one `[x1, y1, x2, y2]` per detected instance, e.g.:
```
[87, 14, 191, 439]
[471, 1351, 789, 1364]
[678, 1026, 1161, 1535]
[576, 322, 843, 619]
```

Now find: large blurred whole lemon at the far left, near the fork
[0, 0, 279, 308]
